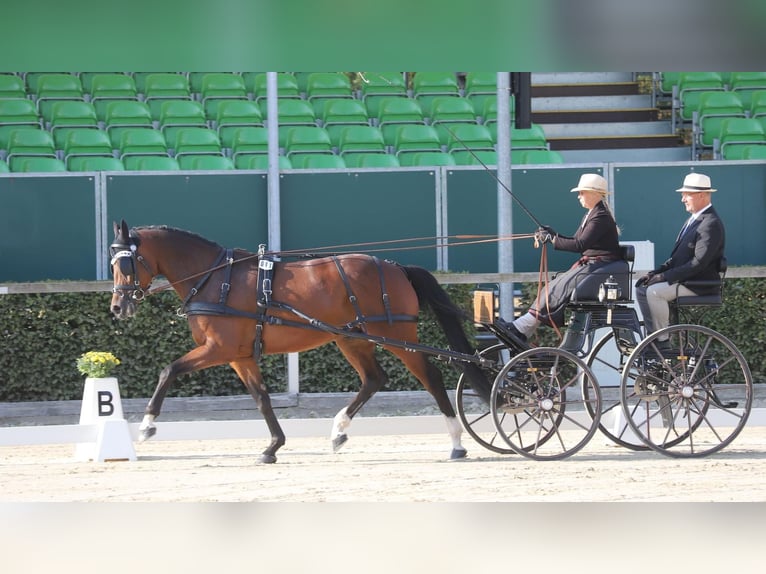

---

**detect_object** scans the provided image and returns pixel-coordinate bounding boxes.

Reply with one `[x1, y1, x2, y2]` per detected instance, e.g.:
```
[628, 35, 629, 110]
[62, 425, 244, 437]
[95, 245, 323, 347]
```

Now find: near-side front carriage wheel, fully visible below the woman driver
[490, 347, 601, 460]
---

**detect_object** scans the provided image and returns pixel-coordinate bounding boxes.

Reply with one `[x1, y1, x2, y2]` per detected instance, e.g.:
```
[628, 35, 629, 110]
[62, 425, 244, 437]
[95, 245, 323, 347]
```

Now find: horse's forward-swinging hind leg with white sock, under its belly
[330, 339, 388, 452]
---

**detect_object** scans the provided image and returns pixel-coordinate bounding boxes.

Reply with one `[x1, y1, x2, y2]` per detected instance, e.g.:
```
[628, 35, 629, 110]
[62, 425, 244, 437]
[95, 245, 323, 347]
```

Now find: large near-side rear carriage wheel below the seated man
[620, 325, 753, 458]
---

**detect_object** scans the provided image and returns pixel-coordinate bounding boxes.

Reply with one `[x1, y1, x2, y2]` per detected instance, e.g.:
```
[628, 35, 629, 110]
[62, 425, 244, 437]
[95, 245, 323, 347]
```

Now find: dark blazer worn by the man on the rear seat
[656, 205, 726, 295]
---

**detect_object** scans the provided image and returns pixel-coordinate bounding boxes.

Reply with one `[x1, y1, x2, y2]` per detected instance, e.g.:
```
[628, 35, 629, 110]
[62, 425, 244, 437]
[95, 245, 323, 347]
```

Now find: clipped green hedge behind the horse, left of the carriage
[0, 285, 473, 402]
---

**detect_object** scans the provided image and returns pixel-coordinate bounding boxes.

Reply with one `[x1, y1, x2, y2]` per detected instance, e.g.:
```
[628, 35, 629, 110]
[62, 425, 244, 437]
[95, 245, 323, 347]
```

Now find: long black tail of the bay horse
[402, 265, 491, 402]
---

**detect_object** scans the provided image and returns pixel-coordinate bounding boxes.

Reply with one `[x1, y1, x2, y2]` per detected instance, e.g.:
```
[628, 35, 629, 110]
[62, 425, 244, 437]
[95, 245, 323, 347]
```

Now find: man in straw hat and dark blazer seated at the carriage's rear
[636, 173, 725, 348]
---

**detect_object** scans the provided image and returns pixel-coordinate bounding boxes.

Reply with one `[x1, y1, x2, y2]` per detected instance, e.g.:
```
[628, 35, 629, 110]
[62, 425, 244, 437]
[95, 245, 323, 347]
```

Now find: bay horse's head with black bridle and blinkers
[109, 219, 152, 319]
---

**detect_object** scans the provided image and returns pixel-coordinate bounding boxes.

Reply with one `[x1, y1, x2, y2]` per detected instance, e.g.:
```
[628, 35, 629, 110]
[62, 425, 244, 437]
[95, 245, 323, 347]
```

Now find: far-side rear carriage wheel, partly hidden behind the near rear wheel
[581, 330, 649, 450]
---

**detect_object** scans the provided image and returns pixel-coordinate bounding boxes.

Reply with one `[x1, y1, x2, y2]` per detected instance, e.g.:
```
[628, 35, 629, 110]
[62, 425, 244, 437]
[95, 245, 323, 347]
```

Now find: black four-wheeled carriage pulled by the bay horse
[456, 245, 753, 460]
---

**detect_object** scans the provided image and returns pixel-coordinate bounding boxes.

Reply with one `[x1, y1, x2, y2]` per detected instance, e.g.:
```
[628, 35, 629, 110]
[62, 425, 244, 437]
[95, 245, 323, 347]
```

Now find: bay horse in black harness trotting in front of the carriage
[110, 220, 490, 463]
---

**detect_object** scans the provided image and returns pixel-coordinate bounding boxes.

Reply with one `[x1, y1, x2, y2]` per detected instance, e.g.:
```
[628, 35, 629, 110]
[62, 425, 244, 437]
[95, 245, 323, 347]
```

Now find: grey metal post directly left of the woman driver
[497, 72, 513, 321]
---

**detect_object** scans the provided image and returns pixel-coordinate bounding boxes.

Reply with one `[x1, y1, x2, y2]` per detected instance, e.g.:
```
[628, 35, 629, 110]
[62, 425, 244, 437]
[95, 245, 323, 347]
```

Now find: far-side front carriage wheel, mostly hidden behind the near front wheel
[455, 343, 514, 454]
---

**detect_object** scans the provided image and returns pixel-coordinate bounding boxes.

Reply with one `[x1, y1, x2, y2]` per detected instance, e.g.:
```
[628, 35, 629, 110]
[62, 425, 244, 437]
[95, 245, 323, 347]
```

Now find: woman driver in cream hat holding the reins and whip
[495, 173, 630, 349]
